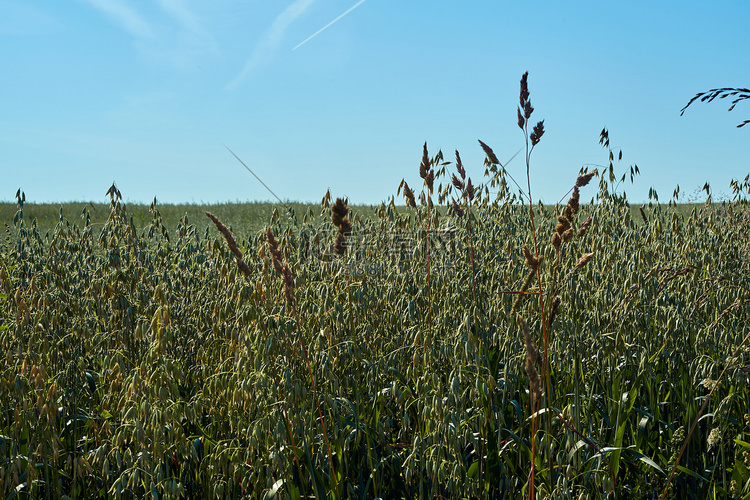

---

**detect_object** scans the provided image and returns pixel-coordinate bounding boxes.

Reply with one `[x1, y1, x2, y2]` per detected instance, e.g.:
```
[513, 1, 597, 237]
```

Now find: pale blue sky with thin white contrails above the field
[0, 0, 750, 204]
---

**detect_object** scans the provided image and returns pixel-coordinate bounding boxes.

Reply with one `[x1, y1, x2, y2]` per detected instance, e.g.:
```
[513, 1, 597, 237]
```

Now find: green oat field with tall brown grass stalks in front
[0, 77, 750, 499]
